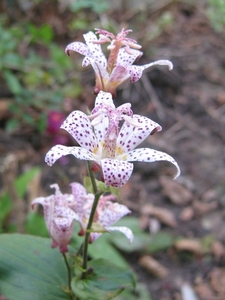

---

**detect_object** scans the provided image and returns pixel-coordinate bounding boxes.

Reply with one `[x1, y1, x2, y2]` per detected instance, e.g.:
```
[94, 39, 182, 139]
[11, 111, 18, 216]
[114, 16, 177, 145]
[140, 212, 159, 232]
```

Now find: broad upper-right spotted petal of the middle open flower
[116, 115, 162, 154]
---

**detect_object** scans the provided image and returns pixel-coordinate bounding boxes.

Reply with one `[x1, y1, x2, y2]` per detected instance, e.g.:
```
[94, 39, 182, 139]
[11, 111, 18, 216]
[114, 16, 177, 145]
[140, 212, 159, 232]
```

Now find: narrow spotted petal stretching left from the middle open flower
[45, 145, 95, 166]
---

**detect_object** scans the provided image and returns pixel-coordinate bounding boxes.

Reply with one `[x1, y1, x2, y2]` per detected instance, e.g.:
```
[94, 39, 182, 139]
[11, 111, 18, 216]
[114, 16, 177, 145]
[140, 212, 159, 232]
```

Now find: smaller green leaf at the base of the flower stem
[72, 258, 135, 300]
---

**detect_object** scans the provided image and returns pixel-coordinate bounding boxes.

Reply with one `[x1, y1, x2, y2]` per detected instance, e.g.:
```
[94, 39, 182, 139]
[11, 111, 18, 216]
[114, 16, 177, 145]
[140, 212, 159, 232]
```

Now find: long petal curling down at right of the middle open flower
[126, 148, 180, 179]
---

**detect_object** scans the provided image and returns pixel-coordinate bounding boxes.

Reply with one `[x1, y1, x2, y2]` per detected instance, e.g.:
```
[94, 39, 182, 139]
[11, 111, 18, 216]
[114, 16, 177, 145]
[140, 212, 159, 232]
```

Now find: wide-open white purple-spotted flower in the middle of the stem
[45, 91, 180, 187]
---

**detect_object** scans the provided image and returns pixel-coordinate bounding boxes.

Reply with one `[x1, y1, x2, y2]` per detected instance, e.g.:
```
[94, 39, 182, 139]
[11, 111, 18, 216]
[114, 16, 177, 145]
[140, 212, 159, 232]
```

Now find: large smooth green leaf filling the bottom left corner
[0, 234, 70, 300]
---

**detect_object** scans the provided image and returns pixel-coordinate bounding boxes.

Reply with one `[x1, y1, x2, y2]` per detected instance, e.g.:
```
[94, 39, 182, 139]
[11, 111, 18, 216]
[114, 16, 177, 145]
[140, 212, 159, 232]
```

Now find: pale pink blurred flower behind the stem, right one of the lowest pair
[71, 183, 133, 243]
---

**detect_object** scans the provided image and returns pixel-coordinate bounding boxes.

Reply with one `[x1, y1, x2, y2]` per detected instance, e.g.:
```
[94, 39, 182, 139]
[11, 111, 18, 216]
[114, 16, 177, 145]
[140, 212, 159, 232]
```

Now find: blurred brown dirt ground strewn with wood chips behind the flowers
[0, 4, 225, 300]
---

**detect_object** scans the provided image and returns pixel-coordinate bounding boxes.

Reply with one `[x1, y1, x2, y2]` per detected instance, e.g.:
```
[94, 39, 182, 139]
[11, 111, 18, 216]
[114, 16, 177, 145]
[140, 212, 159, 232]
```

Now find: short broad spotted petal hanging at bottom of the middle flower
[101, 158, 133, 187]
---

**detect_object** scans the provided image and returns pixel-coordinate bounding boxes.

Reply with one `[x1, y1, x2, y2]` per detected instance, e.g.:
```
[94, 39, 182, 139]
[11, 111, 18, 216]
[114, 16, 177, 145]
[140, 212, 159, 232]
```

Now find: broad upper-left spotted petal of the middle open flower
[61, 110, 98, 151]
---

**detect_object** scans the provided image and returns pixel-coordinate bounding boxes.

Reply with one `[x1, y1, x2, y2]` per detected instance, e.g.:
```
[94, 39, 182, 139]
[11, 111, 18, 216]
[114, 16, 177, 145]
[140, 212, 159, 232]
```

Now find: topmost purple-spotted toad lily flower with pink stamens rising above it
[65, 29, 173, 97]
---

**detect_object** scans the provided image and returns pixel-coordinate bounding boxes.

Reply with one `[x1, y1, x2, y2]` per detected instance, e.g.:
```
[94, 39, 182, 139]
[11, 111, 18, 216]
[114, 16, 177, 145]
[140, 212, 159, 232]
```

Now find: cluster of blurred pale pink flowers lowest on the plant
[32, 182, 133, 252]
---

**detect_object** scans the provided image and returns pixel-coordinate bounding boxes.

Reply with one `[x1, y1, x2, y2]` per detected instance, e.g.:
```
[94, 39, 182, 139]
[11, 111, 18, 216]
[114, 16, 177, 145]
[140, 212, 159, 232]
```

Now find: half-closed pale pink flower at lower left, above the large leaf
[31, 184, 78, 252]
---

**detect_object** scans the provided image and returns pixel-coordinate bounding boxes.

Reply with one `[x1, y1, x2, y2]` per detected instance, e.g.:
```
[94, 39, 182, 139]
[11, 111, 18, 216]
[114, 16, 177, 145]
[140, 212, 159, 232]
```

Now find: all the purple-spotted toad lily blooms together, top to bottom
[32, 29, 180, 253]
